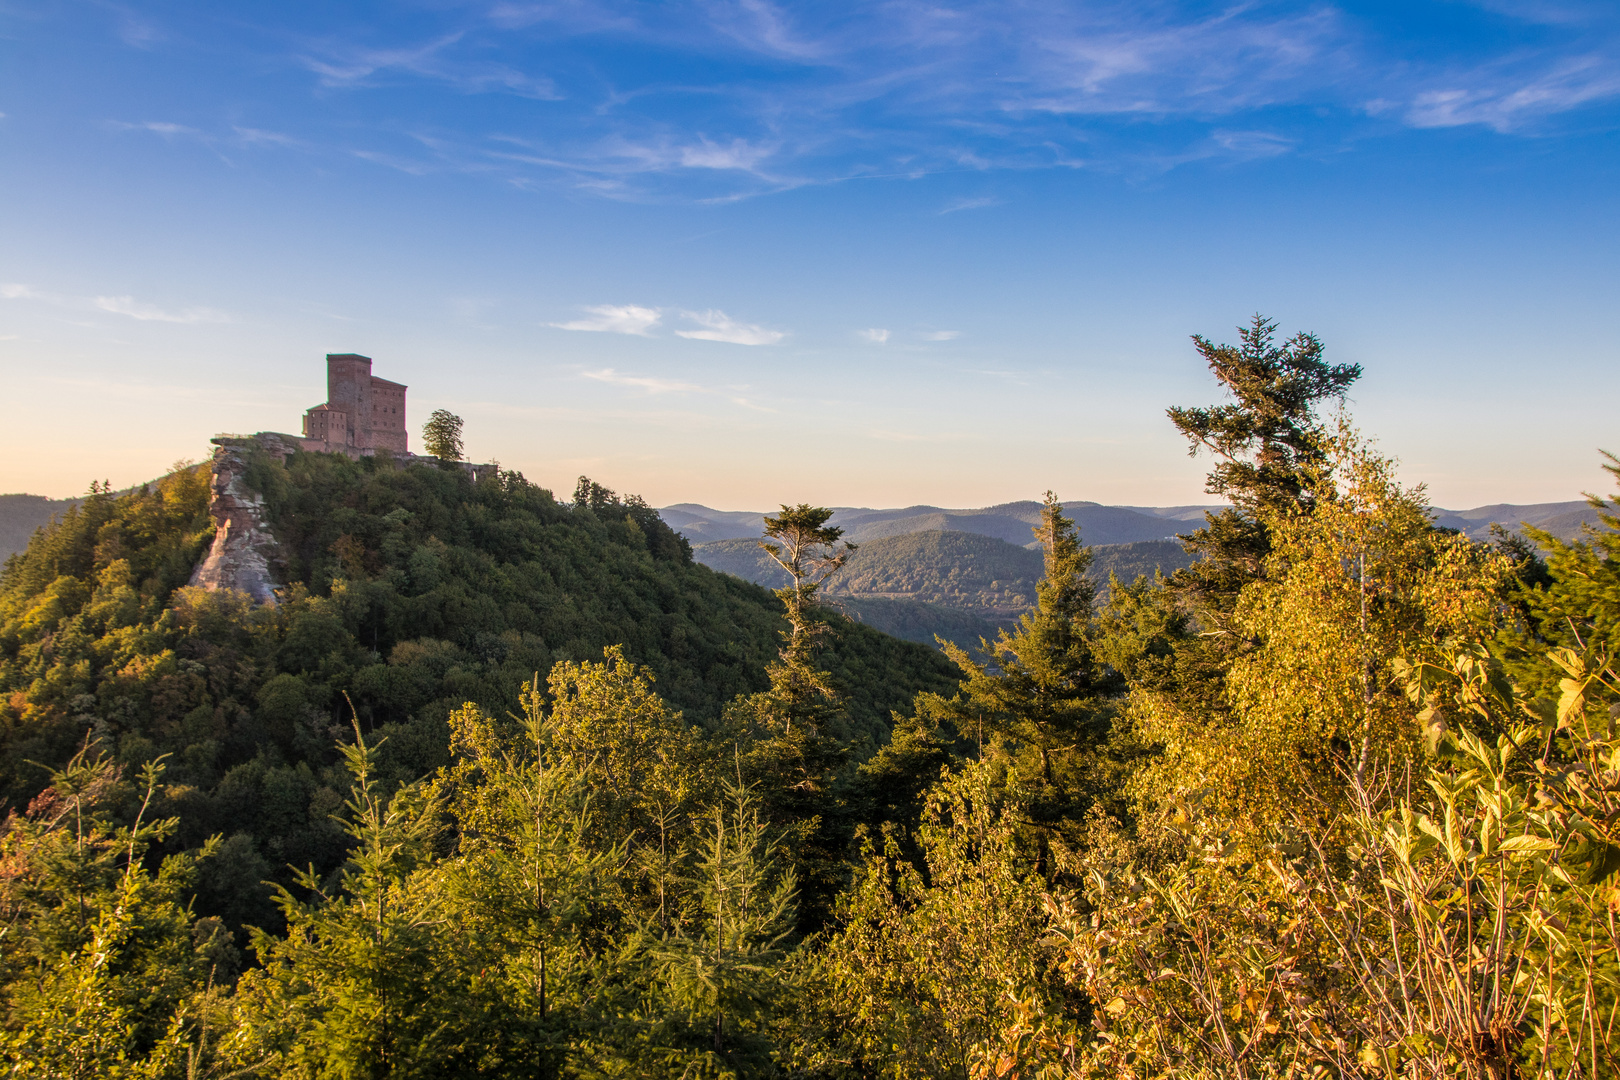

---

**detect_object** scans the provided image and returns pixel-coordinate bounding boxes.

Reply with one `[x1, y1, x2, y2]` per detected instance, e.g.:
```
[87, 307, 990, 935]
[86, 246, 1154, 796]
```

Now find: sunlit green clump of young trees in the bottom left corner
[0, 745, 238, 1080]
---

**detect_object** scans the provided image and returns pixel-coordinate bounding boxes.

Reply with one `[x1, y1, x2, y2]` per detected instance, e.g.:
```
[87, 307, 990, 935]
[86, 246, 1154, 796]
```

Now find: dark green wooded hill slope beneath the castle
[0, 453, 954, 920]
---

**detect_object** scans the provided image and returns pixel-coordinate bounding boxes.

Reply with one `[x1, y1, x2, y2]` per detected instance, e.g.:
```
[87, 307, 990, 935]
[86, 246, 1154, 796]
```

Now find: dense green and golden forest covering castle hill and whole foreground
[0, 317, 1620, 1080]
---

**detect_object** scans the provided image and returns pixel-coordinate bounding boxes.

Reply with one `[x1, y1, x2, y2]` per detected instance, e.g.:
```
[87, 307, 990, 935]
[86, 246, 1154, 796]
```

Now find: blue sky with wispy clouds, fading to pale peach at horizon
[0, 0, 1620, 508]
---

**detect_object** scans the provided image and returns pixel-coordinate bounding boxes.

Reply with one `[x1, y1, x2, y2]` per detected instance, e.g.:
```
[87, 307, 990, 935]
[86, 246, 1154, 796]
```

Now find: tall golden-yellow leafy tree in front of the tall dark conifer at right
[1134, 427, 1510, 836]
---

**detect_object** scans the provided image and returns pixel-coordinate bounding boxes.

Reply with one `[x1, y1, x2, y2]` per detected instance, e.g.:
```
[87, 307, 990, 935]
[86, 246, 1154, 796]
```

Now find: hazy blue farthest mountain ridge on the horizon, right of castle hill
[659, 500, 1597, 547]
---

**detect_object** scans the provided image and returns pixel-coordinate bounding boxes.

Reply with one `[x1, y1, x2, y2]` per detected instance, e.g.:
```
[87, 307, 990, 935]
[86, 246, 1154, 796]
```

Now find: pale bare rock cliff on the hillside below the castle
[191, 434, 296, 604]
